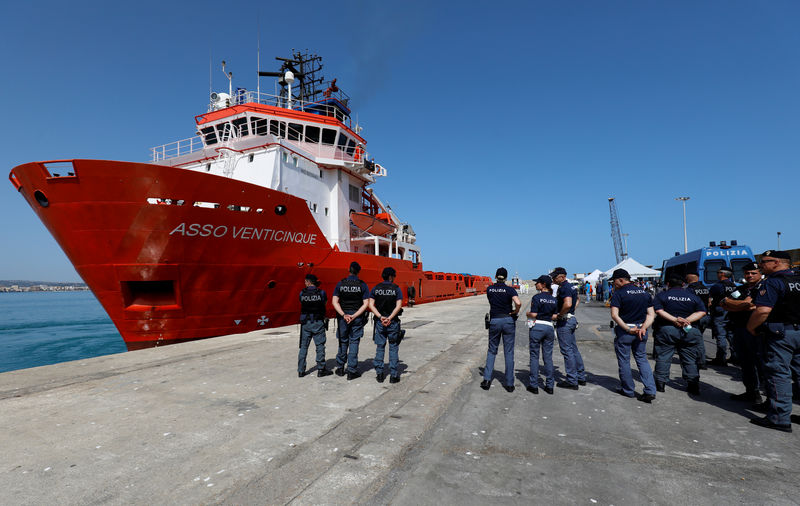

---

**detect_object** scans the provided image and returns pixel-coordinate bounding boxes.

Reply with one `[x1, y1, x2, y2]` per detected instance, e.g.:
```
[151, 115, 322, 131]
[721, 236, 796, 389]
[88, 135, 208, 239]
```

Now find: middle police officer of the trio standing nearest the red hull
[331, 262, 369, 380]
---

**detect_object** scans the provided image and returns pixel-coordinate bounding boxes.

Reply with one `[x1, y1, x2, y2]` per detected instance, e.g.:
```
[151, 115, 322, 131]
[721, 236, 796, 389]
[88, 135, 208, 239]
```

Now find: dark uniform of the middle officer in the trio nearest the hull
[333, 275, 369, 374]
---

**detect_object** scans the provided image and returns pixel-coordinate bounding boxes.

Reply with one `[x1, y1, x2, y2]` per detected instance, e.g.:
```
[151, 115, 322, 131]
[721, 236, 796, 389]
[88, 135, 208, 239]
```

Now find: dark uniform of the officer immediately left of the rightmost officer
[728, 283, 765, 398]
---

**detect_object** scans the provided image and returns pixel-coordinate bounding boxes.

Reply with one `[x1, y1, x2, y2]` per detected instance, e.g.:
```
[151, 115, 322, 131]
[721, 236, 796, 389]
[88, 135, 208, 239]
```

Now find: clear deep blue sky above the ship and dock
[0, 0, 800, 281]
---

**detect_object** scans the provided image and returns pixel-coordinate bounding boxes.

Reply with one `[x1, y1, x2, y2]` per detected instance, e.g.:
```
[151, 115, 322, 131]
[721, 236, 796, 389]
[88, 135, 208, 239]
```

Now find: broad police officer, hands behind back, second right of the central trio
[653, 276, 706, 395]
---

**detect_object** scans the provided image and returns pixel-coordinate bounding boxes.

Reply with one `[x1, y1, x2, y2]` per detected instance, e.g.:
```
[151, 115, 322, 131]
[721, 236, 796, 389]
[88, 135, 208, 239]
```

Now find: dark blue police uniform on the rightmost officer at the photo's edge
[753, 269, 800, 429]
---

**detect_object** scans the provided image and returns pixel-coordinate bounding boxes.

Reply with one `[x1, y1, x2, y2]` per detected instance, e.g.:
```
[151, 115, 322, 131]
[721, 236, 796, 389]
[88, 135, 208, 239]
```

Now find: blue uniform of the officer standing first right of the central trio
[610, 283, 656, 397]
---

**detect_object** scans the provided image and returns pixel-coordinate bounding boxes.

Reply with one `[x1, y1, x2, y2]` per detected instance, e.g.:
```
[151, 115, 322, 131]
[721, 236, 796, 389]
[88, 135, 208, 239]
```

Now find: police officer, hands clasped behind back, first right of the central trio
[610, 269, 656, 403]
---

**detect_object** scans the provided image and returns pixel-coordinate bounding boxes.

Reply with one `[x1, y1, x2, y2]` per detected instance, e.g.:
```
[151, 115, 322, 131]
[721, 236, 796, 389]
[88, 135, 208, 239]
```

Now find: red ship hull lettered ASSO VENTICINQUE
[9, 160, 491, 349]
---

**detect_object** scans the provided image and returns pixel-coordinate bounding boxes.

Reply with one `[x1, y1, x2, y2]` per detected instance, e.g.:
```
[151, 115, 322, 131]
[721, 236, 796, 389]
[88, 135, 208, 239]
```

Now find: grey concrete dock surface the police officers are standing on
[0, 296, 800, 504]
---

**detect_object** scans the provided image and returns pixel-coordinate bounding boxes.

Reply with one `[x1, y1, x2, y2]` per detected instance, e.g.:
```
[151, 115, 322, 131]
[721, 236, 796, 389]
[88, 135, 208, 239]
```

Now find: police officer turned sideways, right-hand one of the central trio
[550, 267, 586, 390]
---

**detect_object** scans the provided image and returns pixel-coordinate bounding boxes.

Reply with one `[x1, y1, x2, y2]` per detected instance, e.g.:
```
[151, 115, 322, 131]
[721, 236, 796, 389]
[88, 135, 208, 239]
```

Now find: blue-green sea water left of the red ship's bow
[0, 291, 127, 372]
